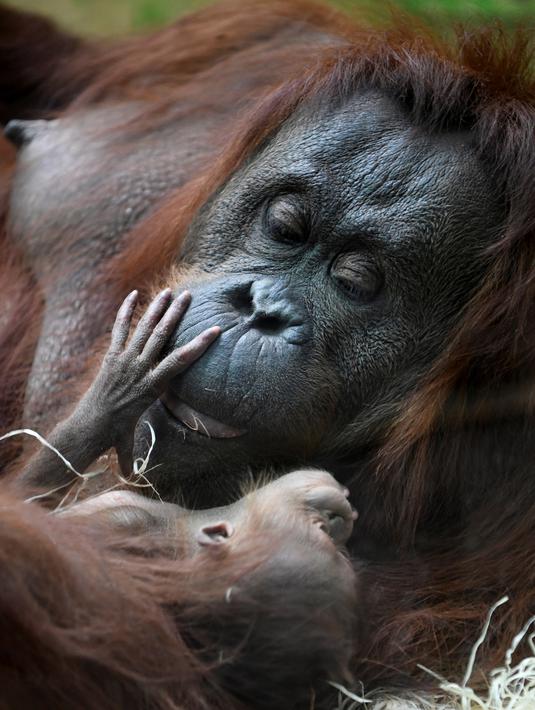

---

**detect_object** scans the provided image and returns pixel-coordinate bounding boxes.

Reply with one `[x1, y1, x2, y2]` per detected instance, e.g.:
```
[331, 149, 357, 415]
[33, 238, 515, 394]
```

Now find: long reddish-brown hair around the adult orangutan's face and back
[0, 2, 535, 708]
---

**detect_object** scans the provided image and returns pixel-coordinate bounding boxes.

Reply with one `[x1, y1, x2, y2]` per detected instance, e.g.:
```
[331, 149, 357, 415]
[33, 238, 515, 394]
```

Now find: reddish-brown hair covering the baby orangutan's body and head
[0, 493, 356, 710]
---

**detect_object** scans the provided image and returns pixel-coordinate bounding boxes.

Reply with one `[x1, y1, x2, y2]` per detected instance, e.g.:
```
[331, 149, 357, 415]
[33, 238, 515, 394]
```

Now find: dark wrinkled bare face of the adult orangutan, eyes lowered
[135, 93, 501, 505]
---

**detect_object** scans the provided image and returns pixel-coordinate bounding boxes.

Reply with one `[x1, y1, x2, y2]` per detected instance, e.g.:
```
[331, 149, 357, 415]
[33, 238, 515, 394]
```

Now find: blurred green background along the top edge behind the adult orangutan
[4, 0, 535, 35]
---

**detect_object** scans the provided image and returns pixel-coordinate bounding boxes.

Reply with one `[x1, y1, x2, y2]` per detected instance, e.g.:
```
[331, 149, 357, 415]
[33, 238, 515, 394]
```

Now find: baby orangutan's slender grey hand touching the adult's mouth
[79, 288, 221, 473]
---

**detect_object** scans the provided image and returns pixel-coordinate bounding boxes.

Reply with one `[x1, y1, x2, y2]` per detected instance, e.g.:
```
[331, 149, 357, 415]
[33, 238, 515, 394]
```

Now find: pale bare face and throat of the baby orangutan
[68, 469, 358, 620]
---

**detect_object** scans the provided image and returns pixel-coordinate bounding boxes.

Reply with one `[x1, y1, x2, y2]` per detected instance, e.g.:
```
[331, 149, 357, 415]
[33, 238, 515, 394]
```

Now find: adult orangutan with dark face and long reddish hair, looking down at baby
[0, 2, 535, 708]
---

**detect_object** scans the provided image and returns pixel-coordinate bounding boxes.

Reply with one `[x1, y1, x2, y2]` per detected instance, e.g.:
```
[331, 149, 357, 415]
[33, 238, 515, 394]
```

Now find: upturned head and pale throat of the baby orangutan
[67, 470, 361, 709]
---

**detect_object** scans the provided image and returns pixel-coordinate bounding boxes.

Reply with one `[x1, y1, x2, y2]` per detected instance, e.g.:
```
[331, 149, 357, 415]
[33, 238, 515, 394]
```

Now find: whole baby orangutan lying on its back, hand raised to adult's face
[0, 291, 358, 710]
